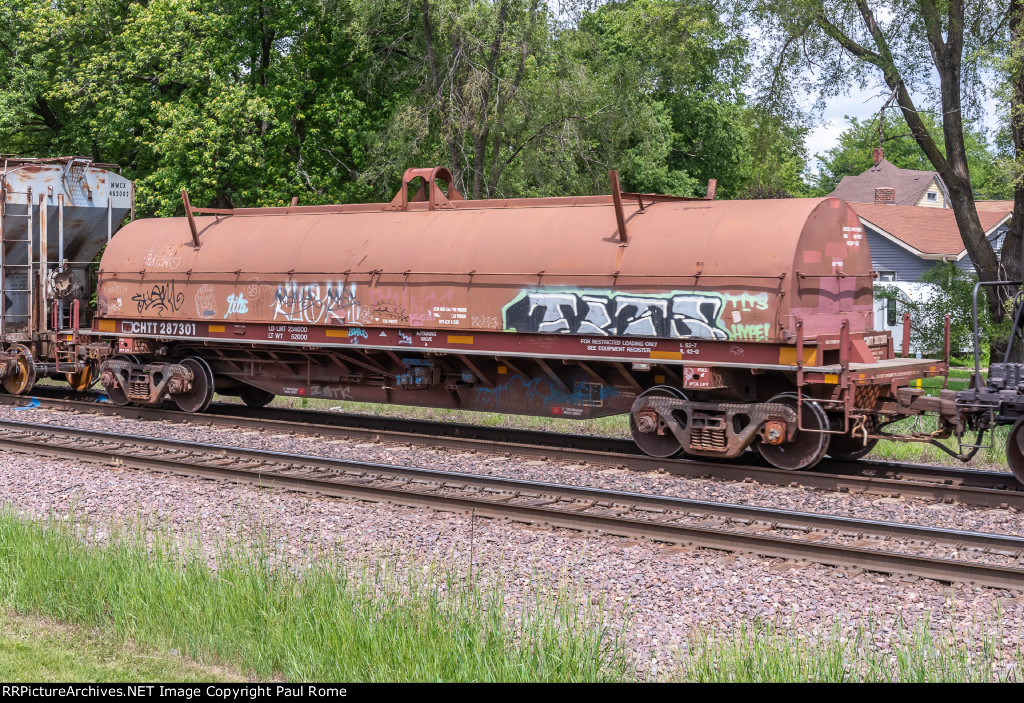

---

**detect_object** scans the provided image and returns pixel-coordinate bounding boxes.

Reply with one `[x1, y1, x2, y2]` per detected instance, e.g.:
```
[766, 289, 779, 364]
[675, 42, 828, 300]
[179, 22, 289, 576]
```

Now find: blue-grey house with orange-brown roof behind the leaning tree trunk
[850, 201, 1014, 281]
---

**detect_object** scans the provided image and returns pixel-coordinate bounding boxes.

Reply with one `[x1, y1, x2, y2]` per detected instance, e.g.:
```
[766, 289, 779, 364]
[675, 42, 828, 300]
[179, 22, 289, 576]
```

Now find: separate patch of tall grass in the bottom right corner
[672, 619, 1024, 683]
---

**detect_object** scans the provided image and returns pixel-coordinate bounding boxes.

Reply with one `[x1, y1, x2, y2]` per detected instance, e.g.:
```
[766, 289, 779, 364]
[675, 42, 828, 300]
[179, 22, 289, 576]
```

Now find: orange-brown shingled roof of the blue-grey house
[850, 201, 1014, 259]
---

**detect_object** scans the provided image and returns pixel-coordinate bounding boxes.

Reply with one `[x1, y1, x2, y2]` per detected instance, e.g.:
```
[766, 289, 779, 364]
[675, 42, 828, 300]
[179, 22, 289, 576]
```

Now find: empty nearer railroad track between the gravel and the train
[0, 422, 1024, 590]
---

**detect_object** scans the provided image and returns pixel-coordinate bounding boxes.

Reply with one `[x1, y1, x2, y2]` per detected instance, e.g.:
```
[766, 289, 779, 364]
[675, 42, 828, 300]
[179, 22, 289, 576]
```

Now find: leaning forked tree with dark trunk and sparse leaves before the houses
[758, 0, 1021, 318]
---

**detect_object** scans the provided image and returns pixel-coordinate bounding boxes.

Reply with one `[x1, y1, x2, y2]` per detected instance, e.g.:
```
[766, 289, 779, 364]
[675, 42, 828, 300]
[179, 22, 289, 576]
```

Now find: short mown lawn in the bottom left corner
[0, 612, 240, 683]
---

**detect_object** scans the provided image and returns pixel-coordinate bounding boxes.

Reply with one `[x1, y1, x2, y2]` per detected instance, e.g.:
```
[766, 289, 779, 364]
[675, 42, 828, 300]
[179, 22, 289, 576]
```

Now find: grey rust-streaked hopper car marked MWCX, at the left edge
[0, 155, 135, 386]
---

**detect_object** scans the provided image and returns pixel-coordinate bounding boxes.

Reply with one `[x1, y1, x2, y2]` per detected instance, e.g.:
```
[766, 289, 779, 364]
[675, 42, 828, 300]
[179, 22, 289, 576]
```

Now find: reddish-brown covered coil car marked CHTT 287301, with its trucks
[0, 168, 1024, 478]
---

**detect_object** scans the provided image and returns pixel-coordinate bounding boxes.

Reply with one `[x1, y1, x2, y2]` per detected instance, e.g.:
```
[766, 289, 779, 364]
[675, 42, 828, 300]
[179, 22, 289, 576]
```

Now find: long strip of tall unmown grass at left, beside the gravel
[0, 512, 629, 682]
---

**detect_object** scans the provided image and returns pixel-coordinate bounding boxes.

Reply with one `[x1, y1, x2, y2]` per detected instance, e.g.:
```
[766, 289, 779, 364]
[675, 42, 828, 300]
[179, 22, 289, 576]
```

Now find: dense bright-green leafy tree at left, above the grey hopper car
[0, 0, 389, 215]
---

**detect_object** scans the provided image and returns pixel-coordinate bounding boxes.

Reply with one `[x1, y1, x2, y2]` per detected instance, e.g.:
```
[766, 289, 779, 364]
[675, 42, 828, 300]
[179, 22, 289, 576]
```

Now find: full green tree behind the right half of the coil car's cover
[577, 0, 806, 197]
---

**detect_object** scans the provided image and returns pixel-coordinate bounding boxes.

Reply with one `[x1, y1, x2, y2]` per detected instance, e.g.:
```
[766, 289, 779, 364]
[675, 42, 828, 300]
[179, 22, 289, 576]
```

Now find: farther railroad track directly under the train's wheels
[0, 389, 1024, 511]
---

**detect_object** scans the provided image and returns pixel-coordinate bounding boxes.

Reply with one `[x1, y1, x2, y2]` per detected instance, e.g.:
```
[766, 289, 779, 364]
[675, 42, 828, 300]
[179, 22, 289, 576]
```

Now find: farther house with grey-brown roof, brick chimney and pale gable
[828, 148, 949, 209]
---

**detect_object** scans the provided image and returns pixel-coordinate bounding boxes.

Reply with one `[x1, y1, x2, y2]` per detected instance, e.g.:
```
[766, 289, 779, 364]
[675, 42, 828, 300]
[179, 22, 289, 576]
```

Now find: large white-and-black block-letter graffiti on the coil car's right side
[502, 290, 728, 340]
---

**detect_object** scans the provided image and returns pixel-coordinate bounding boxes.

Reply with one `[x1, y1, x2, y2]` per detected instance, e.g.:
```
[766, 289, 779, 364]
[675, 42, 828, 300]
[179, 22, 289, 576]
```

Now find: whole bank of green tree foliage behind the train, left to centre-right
[0, 0, 806, 210]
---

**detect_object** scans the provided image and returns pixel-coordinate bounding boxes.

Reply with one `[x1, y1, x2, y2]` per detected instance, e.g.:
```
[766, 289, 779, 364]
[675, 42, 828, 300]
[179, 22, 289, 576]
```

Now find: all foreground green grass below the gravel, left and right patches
[0, 511, 1024, 682]
